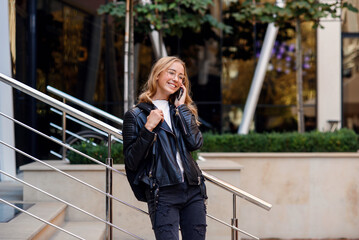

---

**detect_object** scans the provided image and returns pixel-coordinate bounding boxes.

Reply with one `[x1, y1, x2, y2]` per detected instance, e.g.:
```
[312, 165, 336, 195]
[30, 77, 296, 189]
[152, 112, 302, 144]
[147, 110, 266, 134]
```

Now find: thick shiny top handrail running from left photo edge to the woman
[0, 73, 122, 139]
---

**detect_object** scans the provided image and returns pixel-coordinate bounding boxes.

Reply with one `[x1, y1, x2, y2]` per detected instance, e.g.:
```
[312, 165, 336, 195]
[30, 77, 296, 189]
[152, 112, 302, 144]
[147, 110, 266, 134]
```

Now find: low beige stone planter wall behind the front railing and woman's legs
[21, 160, 245, 240]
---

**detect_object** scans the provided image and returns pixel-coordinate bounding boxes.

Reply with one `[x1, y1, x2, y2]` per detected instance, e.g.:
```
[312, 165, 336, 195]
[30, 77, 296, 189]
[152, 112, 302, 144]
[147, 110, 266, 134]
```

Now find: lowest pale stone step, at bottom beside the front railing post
[50, 222, 106, 240]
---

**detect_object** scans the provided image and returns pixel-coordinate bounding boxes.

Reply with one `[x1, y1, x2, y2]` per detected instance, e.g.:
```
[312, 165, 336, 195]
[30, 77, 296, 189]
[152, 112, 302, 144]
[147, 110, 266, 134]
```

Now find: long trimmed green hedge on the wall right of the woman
[201, 129, 359, 152]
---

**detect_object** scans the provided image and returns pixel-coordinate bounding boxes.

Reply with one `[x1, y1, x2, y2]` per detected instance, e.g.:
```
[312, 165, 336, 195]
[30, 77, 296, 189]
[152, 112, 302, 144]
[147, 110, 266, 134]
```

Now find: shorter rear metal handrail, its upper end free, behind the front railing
[46, 86, 123, 126]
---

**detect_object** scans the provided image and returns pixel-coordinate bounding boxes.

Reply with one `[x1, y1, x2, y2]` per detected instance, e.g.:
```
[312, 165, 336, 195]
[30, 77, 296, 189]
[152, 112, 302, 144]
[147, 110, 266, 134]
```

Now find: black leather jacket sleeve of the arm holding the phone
[176, 104, 203, 151]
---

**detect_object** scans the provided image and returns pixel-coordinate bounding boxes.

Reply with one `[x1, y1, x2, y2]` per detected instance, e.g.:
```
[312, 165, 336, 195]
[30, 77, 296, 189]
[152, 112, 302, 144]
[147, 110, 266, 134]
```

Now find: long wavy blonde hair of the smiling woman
[138, 56, 200, 125]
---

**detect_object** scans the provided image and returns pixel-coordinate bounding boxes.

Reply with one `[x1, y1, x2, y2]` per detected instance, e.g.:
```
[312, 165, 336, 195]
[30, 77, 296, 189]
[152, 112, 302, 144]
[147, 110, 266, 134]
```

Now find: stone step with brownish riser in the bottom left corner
[0, 202, 66, 240]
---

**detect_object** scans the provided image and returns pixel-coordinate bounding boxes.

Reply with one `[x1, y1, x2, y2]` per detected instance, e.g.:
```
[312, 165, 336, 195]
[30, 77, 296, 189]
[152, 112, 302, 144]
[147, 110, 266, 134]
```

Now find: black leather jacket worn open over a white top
[123, 103, 203, 187]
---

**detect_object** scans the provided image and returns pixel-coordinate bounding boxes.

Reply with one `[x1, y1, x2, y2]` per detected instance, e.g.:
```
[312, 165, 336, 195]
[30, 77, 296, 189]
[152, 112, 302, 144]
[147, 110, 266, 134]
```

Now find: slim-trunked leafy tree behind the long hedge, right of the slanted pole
[232, 0, 358, 133]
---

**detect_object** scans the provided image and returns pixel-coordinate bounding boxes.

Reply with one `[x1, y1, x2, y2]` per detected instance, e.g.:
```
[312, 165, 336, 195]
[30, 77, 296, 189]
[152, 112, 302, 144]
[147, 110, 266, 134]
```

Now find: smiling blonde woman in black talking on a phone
[123, 57, 207, 240]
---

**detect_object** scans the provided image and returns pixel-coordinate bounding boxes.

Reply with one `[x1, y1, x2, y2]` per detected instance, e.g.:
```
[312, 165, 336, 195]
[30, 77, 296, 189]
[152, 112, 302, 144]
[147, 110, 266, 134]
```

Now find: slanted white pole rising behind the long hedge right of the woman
[238, 0, 285, 134]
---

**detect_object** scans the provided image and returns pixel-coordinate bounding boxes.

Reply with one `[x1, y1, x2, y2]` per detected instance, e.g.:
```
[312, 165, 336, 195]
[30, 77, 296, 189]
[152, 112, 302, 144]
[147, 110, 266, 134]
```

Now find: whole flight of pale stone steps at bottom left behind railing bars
[0, 182, 106, 240]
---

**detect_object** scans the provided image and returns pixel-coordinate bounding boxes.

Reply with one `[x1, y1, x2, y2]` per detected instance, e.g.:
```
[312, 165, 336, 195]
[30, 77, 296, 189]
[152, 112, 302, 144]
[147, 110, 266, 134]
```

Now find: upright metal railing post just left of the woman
[105, 134, 113, 240]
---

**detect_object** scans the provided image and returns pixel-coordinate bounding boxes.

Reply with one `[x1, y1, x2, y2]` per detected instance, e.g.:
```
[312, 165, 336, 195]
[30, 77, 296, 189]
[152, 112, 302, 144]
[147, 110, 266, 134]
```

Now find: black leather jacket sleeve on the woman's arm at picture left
[122, 110, 155, 171]
